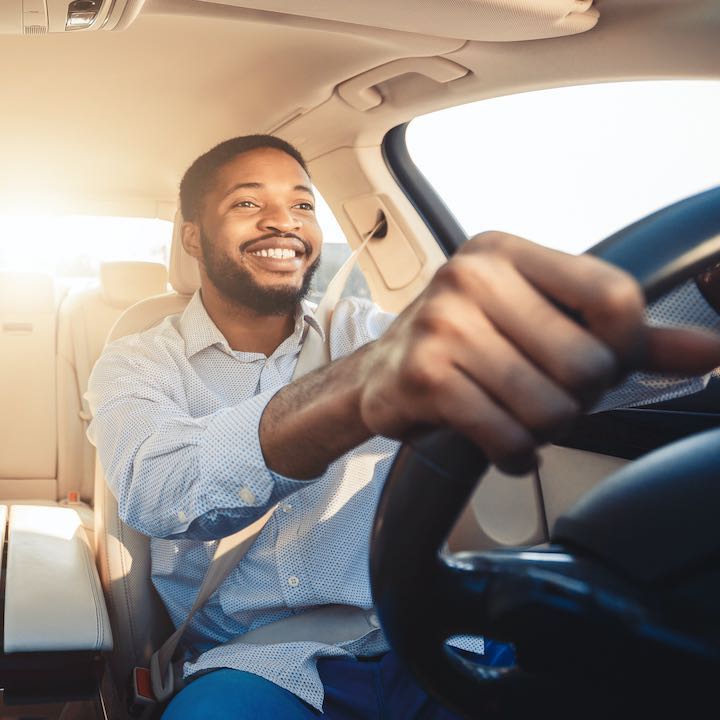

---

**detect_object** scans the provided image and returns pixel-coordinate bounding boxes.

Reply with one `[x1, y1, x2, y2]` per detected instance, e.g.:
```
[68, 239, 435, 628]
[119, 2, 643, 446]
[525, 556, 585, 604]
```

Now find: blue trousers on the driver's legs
[162, 643, 513, 720]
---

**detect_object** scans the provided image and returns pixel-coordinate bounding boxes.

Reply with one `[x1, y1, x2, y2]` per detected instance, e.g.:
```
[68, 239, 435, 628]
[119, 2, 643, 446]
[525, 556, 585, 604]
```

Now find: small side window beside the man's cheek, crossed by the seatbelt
[309, 188, 370, 302]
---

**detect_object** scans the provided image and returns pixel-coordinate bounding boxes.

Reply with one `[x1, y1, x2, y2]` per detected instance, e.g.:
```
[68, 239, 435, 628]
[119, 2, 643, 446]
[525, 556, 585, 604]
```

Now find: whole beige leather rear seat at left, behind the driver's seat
[0, 262, 167, 552]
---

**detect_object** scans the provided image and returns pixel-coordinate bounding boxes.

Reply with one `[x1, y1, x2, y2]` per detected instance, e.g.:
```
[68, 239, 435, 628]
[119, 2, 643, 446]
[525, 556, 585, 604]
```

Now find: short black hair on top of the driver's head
[180, 135, 310, 222]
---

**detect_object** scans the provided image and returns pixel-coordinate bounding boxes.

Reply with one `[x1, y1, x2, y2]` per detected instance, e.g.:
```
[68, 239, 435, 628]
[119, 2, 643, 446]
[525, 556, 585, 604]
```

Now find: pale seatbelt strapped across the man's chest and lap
[145, 218, 385, 701]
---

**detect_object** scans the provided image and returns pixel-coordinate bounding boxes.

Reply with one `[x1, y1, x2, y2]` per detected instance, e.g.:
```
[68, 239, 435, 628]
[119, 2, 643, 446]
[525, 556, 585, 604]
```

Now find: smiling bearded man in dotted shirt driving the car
[90, 136, 720, 720]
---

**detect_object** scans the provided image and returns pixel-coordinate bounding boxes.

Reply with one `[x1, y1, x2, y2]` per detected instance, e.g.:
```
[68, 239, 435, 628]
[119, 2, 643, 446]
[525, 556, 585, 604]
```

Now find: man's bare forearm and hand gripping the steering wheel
[260, 233, 720, 478]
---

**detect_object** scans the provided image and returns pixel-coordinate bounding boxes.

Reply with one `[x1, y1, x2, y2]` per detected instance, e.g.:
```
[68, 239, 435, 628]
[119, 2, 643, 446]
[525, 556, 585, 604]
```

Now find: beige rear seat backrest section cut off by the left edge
[0, 271, 59, 500]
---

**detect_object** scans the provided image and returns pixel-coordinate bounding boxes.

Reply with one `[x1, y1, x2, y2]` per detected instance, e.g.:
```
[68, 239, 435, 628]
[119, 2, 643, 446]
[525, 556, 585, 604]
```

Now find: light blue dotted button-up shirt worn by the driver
[88, 285, 717, 708]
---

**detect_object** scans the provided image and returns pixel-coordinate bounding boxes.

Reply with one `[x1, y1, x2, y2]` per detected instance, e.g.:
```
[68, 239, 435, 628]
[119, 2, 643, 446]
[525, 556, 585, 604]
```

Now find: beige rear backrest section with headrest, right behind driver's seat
[57, 262, 168, 504]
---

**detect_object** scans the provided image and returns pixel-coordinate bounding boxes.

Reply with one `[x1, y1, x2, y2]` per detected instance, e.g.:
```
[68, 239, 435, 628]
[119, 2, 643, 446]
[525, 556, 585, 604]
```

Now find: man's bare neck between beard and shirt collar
[201, 286, 295, 357]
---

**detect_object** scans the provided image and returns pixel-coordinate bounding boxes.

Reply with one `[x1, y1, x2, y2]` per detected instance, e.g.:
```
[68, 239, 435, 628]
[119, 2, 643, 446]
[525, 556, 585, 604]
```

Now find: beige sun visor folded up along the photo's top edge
[194, 0, 598, 41]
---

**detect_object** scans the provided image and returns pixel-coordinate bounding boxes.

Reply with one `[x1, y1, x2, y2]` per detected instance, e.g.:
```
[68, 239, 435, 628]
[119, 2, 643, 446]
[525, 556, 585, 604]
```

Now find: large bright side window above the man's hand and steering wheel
[407, 81, 720, 253]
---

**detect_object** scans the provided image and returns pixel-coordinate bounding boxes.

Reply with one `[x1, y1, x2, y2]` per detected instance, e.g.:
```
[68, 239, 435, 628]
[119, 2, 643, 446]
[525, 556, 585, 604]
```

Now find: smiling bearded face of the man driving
[193, 148, 322, 314]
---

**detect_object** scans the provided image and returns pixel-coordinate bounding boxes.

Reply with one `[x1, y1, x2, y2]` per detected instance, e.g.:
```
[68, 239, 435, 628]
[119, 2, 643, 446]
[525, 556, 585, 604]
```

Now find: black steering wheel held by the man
[370, 188, 720, 718]
